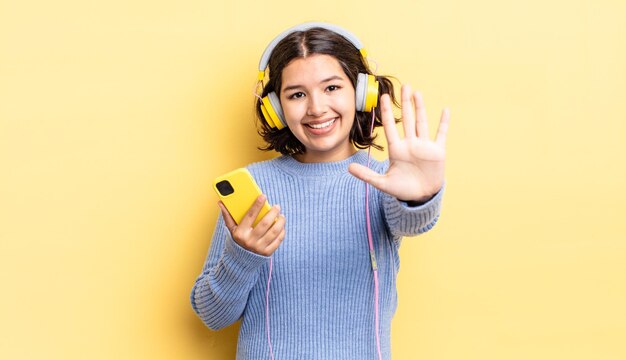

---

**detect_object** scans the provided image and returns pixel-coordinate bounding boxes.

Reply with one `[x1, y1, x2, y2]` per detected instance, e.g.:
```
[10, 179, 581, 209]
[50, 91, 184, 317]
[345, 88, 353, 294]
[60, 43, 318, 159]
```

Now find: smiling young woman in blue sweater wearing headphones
[191, 23, 449, 359]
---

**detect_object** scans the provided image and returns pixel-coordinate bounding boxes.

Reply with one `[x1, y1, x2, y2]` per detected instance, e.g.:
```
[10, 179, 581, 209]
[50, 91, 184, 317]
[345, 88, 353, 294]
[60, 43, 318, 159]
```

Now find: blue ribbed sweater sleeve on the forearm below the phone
[191, 214, 269, 330]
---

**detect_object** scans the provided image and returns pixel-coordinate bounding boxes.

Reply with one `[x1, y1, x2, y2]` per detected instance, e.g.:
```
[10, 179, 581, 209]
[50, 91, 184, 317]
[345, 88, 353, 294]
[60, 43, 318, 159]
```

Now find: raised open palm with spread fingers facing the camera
[349, 85, 450, 202]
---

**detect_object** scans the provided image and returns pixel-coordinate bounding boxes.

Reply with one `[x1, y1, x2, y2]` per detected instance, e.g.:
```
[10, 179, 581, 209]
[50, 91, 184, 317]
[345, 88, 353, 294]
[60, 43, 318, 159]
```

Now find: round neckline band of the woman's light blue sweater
[276, 150, 367, 177]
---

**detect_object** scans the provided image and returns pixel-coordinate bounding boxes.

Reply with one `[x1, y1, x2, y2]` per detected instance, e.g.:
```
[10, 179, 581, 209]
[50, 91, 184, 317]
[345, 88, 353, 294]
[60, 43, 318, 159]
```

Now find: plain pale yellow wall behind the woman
[0, 0, 626, 360]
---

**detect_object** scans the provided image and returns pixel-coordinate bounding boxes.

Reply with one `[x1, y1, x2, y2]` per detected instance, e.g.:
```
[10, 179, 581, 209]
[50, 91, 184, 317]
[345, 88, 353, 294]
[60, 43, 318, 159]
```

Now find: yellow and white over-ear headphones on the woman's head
[258, 22, 378, 130]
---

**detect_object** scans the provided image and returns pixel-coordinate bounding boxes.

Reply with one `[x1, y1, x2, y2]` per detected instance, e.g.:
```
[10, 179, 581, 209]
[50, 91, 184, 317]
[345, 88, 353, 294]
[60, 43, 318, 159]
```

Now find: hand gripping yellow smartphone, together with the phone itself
[213, 168, 285, 256]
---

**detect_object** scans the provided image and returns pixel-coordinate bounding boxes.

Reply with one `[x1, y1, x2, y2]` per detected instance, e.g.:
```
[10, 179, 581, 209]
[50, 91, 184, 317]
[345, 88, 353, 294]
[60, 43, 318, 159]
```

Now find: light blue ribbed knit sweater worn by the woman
[191, 151, 442, 360]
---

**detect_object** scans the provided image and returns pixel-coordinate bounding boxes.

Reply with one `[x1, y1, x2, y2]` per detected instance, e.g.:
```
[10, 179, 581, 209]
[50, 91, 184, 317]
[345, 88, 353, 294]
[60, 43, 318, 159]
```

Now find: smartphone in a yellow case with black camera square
[213, 168, 271, 226]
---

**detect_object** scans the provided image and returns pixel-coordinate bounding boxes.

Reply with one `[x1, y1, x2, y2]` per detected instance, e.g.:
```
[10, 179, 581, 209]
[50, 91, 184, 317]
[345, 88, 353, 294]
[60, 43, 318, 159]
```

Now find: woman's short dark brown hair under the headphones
[256, 28, 398, 155]
